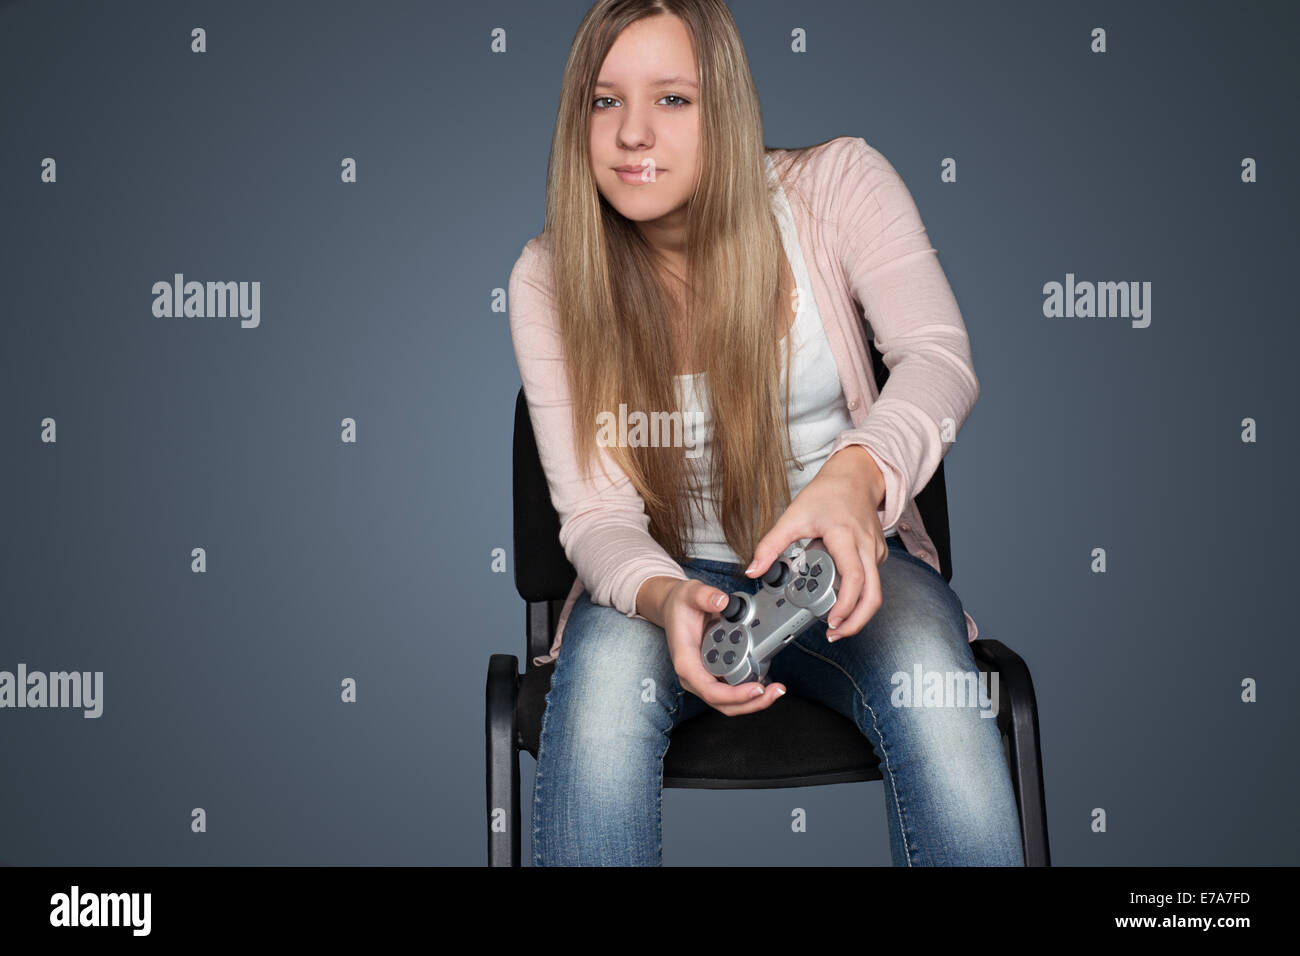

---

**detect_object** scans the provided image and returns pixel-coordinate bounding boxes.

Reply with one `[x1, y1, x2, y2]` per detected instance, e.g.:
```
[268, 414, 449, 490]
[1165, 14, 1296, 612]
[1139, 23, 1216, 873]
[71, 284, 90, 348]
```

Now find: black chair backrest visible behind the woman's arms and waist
[514, 338, 953, 662]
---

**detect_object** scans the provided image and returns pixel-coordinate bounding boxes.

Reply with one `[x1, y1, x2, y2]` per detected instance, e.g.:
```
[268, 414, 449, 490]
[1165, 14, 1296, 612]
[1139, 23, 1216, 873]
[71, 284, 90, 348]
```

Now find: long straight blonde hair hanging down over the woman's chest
[542, 0, 837, 562]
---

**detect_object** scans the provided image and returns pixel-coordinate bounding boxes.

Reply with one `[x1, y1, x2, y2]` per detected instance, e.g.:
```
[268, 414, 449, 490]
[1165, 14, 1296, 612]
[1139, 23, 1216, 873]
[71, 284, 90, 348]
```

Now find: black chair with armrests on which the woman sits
[486, 339, 1050, 866]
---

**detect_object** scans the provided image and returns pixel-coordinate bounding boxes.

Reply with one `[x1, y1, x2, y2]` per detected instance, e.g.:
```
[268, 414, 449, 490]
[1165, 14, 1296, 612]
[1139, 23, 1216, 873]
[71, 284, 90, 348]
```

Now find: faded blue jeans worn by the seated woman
[533, 536, 1024, 866]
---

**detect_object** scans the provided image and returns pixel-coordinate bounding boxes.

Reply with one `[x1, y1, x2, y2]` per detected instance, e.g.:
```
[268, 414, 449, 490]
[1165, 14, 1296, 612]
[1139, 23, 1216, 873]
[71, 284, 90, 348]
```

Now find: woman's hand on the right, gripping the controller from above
[745, 445, 889, 641]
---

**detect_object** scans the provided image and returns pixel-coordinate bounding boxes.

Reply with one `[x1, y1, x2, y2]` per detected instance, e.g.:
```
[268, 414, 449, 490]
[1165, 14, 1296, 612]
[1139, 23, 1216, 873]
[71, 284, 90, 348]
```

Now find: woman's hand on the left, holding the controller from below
[663, 578, 785, 717]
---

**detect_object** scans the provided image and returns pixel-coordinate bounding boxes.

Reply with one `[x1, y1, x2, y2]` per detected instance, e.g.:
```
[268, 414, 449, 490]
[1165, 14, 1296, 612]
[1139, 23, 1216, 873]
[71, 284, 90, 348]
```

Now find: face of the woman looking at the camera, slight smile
[590, 14, 699, 222]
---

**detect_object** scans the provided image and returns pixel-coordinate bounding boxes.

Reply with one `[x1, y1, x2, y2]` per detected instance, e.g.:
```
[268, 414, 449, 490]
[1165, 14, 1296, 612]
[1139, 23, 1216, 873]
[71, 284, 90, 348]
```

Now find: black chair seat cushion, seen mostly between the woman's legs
[515, 661, 880, 790]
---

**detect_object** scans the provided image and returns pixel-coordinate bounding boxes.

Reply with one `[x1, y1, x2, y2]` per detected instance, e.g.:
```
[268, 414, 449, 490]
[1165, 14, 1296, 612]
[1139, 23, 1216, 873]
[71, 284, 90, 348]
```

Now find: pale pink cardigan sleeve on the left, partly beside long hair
[507, 238, 688, 620]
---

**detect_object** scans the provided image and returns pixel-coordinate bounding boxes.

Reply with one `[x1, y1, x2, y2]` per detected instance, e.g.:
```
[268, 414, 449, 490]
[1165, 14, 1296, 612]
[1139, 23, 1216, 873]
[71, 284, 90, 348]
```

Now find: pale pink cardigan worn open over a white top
[508, 137, 980, 665]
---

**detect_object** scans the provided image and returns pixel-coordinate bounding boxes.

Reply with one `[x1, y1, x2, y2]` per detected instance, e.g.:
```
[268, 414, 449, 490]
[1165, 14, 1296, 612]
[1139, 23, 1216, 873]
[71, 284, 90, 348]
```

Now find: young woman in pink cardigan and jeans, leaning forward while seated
[510, 0, 1023, 865]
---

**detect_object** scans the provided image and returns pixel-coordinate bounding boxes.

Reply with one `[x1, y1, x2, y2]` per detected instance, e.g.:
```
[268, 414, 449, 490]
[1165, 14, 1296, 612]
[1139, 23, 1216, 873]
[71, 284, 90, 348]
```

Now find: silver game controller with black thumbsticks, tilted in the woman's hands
[699, 537, 840, 684]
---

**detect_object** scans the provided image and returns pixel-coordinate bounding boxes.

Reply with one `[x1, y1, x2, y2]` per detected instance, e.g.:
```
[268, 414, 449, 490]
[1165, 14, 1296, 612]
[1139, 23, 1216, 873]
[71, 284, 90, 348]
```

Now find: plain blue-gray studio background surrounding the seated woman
[0, 0, 1300, 865]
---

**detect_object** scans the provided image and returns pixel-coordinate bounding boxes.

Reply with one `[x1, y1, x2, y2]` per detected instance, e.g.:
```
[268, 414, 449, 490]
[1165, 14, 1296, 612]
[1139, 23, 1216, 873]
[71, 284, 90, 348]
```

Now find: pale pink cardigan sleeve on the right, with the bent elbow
[827, 137, 980, 533]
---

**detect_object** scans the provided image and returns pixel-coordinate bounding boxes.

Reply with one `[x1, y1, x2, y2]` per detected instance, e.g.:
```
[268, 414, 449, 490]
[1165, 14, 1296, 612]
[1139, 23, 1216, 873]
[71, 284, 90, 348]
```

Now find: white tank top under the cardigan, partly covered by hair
[675, 157, 894, 564]
